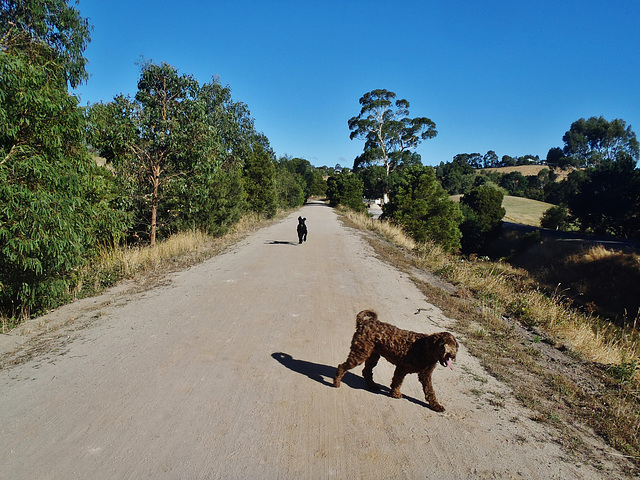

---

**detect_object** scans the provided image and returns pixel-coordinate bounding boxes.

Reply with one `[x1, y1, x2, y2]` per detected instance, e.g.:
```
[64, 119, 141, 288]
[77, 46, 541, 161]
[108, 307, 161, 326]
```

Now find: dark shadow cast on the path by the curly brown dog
[271, 352, 428, 408]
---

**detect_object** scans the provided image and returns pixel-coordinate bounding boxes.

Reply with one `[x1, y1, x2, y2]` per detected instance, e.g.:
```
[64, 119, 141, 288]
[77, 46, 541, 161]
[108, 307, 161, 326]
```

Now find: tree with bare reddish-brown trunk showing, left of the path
[88, 63, 218, 246]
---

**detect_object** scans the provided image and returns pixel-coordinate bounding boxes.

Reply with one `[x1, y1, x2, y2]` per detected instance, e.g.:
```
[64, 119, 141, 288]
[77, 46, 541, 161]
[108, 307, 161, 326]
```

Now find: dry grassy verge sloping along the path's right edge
[342, 211, 640, 476]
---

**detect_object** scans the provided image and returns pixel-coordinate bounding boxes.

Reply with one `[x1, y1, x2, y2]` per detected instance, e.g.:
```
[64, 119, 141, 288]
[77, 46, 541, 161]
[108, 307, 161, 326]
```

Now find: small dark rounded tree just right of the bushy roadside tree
[460, 185, 506, 254]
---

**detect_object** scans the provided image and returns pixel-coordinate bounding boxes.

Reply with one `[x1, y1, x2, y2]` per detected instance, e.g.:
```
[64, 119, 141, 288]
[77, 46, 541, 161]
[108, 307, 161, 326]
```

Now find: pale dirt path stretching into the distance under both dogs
[0, 204, 618, 480]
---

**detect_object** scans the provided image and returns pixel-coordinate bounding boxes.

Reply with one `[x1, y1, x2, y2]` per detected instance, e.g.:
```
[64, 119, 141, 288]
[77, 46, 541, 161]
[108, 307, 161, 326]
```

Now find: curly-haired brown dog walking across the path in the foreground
[333, 310, 458, 412]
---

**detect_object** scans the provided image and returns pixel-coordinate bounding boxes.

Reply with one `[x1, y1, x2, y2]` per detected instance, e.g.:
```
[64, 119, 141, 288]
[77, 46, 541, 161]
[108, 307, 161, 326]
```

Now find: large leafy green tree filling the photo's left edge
[0, 1, 126, 315]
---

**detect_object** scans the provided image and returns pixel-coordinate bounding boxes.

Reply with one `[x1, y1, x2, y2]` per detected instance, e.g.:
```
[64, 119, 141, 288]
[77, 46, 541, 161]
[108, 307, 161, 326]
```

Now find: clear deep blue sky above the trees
[76, 0, 640, 167]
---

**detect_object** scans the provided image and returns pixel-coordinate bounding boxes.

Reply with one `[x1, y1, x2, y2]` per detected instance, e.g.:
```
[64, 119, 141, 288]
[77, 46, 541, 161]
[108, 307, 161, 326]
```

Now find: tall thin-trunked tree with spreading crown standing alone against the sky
[348, 89, 438, 201]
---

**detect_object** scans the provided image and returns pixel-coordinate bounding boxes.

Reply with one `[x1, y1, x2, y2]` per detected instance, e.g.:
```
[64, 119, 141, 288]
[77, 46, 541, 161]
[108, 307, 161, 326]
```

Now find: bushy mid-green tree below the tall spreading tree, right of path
[383, 165, 462, 250]
